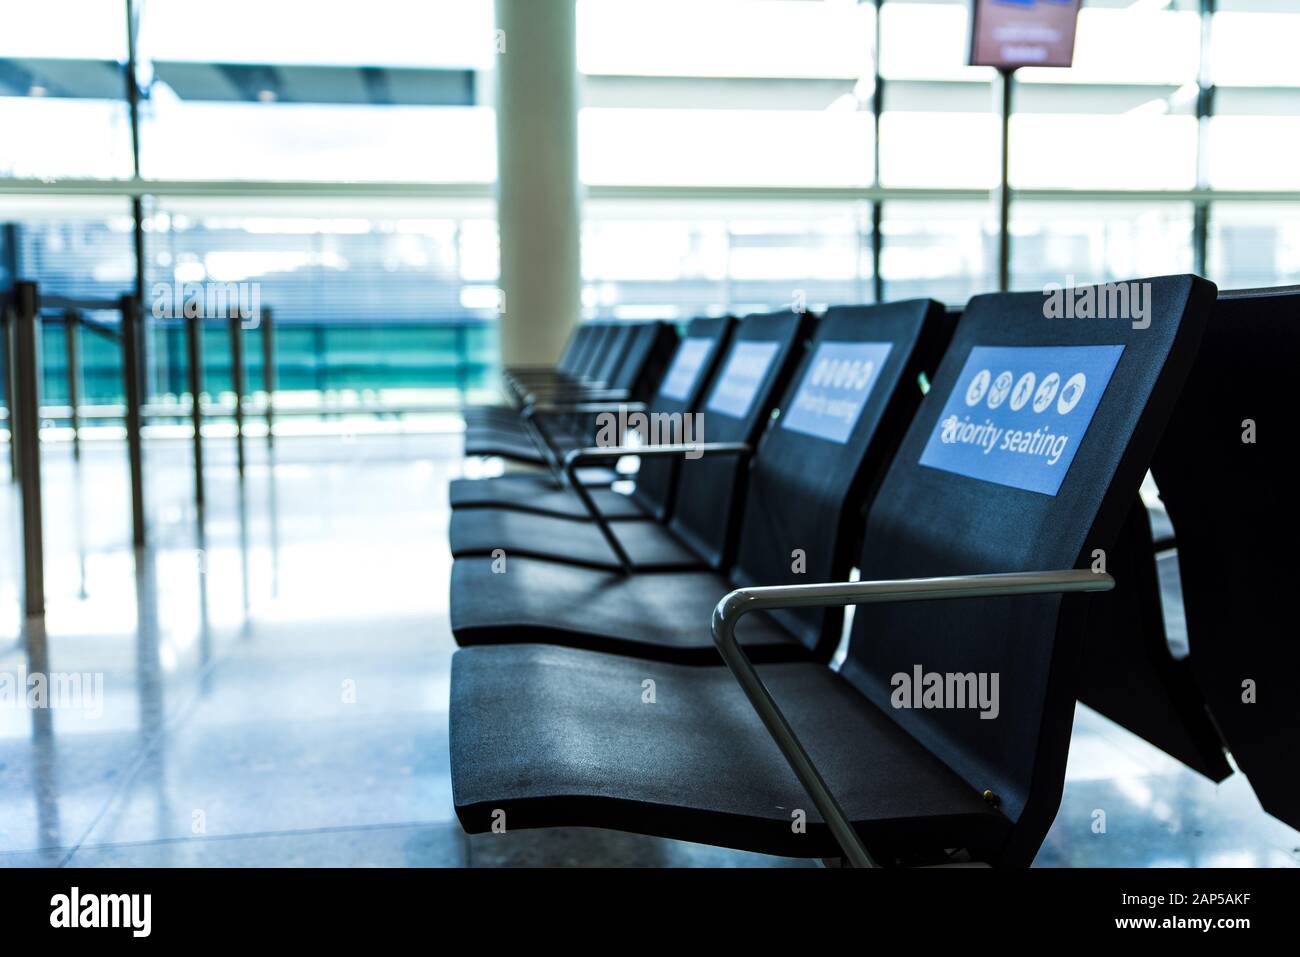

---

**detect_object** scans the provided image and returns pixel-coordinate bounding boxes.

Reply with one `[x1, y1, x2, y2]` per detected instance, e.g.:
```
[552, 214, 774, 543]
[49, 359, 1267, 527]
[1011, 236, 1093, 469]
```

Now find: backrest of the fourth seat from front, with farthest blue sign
[632, 316, 736, 521]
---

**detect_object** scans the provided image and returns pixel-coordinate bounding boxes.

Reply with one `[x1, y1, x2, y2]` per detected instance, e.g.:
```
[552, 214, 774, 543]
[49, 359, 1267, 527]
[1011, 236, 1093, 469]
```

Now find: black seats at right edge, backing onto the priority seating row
[1079, 286, 1300, 830]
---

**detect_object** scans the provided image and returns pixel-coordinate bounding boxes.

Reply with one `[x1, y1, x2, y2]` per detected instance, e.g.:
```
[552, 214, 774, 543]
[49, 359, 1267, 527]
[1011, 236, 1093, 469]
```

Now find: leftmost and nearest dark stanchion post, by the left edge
[9, 282, 46, 618]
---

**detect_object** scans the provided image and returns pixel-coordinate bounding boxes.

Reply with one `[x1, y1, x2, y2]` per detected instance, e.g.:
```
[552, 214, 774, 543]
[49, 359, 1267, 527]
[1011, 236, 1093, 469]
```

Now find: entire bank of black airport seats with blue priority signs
[450, 276, 1297, 865]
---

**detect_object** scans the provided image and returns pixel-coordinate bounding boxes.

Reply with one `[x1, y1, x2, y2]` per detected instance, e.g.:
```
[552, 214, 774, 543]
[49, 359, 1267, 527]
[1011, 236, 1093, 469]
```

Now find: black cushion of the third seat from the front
[447, 508, 705, 571]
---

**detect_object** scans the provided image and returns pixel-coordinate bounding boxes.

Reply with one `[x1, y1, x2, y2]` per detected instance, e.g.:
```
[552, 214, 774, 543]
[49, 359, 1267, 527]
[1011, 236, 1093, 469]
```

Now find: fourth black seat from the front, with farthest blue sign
[450, 316, 735, 521]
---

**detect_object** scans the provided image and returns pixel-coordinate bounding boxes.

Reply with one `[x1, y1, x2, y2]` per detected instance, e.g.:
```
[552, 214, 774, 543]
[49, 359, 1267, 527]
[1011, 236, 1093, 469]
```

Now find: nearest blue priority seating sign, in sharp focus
[920, 346, 1125, 495]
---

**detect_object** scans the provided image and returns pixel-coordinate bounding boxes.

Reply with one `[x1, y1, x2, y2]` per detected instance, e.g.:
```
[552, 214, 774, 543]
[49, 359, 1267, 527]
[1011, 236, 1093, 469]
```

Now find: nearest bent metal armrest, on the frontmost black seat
[712, 568, 1115, 867]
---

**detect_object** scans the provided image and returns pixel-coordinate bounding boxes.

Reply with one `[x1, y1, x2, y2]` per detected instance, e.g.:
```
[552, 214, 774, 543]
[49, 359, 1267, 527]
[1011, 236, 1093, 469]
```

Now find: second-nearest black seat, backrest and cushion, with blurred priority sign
[451, 299, 949, 664]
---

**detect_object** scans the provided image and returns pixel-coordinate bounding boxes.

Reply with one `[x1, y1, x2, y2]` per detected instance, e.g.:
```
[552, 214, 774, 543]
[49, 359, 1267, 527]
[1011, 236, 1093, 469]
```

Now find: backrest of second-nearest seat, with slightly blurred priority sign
[731, 299, 950, 659]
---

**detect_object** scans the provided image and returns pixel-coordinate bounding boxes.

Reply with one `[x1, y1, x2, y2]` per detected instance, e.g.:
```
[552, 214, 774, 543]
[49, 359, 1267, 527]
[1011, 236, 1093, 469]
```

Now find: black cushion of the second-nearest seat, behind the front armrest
[451, 557, 809, 666]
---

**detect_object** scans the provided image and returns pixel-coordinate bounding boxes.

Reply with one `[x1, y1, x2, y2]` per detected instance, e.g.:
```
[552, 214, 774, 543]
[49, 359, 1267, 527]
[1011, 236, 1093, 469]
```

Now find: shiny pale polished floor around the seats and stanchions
[0, 432, 1300, 866]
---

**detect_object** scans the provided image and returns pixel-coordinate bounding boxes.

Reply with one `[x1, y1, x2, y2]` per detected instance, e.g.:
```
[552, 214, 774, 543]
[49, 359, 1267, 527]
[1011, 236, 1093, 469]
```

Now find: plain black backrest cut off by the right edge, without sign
[1152, 287, 1300, 827]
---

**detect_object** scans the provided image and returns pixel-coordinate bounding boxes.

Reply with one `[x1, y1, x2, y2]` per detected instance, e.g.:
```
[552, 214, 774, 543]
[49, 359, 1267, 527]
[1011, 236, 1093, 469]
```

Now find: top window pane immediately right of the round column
[579, 0, 874, 186]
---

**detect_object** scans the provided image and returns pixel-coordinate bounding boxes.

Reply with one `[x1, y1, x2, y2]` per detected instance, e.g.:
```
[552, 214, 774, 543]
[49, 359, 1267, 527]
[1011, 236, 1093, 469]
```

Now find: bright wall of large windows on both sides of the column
[0, 0, 1300, 395]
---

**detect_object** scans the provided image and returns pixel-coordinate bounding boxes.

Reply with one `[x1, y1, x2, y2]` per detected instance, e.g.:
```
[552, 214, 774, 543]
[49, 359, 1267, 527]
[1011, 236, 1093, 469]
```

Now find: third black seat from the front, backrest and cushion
[449, 312, 813, 571]
